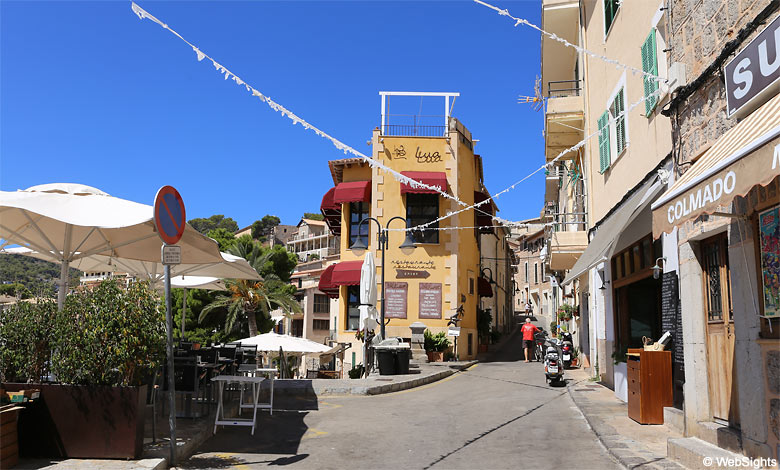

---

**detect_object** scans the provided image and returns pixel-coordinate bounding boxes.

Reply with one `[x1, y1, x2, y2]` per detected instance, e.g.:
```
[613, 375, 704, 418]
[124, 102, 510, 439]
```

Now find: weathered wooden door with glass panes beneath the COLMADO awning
[701, 233, 739, 427]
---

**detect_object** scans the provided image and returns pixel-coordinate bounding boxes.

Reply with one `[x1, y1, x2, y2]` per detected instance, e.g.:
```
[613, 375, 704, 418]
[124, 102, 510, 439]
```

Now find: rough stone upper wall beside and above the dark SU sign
[668, 0, 777, 165]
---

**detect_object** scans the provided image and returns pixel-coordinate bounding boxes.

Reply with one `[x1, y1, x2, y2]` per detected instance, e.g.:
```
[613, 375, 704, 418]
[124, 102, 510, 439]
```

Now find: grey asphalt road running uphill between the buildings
[179, 330, 620, 470]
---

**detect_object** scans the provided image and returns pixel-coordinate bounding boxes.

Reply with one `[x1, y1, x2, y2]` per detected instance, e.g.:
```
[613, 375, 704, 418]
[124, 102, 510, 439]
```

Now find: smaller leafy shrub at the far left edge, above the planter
[0, 298, 57, 382]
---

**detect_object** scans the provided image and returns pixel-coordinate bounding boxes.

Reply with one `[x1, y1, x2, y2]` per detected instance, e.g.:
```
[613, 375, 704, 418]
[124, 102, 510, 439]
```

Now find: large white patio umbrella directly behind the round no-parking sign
[0, 183, 230, 307]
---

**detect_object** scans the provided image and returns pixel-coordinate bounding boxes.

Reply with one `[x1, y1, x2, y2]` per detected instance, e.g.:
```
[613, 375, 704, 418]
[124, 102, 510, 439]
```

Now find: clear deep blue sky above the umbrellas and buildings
[0, 0, 544, 226]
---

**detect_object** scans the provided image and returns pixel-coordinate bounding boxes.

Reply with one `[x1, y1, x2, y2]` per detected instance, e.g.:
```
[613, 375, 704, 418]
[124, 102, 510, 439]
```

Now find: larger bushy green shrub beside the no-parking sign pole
[52, 280, 165, 386]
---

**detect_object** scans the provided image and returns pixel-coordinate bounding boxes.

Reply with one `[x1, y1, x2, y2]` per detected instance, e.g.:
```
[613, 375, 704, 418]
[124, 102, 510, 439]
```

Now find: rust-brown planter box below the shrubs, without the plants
[3, 383, 147, 459]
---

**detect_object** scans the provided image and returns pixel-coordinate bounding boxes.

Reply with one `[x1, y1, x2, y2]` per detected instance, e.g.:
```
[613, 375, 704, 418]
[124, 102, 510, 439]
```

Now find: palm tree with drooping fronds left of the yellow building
[198, 237, 302, 336]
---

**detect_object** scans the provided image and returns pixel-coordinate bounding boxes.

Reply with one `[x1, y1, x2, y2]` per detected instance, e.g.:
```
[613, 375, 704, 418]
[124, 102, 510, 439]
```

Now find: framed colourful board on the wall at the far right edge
[758, 206, 780, 317]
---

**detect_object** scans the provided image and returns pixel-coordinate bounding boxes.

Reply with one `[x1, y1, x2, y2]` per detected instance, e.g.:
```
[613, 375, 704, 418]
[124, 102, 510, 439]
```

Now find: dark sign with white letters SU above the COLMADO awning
[723, 17, 780, 116]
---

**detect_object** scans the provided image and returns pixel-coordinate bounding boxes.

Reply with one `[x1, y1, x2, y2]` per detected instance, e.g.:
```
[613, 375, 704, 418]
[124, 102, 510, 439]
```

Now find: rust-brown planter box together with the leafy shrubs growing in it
[0, 280, 165, 459]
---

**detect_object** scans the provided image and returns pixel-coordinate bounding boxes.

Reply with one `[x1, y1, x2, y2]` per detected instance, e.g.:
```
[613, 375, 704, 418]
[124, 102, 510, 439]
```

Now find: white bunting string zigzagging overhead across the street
[131, 0, 663, 231]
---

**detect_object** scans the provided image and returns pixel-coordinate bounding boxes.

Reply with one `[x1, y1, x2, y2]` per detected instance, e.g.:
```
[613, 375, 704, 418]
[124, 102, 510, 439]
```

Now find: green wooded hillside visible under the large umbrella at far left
[0, 254, 81, 295]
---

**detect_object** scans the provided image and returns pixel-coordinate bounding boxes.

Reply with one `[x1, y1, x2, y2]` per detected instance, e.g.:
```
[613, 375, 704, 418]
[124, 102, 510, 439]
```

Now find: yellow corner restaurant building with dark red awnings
[320, 94, 490, 367]
